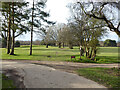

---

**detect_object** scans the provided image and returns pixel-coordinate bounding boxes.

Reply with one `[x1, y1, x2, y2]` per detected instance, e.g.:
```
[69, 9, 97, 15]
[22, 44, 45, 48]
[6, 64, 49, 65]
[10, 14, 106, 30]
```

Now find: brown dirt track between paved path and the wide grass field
[3, 60, 118, 74]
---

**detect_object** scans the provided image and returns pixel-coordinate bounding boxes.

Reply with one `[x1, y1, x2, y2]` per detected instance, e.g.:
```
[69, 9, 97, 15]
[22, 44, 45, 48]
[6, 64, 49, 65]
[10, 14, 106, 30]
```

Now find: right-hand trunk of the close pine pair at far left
[10, 2, 15, 55]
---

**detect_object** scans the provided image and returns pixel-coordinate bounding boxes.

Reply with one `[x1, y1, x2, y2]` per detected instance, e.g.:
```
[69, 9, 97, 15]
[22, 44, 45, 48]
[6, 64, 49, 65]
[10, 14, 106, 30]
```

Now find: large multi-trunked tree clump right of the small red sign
[67, 3, 106, 60]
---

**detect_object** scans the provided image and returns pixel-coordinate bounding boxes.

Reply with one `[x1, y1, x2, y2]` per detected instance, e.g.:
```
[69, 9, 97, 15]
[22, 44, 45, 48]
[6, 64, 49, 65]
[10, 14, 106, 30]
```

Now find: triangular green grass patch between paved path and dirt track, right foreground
[77, 68, 120, 88]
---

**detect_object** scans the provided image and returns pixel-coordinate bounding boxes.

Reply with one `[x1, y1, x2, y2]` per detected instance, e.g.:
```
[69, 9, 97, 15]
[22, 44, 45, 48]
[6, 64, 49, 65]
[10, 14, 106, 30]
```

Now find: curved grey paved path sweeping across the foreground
[2, 61, 105, 88]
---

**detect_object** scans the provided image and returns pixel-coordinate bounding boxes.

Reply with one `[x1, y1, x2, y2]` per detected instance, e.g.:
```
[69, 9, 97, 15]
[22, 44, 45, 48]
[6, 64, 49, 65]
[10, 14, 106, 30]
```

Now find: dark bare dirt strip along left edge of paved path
[2, 69, 25, 88]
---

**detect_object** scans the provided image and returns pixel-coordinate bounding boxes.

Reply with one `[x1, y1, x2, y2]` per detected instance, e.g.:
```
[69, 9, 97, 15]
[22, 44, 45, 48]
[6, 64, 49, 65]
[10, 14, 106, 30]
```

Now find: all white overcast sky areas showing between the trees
[16, 0, 118, 41]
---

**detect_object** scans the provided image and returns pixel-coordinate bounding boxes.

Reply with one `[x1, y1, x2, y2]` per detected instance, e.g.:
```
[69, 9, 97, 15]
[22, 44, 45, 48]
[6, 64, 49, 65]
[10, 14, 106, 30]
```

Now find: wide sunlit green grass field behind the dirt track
[0, 45, 120, 63]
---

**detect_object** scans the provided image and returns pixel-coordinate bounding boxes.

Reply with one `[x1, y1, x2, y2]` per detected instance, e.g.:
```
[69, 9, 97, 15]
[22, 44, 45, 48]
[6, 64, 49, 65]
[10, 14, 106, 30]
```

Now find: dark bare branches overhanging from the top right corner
[77, 2, 120, 37]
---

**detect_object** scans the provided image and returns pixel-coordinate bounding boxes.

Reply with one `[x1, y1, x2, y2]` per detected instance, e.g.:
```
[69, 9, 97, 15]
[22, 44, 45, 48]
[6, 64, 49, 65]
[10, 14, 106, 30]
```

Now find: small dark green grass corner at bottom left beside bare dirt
[0, 74, 16, 89]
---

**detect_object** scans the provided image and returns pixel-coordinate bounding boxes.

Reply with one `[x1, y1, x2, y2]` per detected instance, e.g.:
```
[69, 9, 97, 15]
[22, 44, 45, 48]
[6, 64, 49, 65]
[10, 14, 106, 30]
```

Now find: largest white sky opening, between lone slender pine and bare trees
[47, 0, 70, 23]
